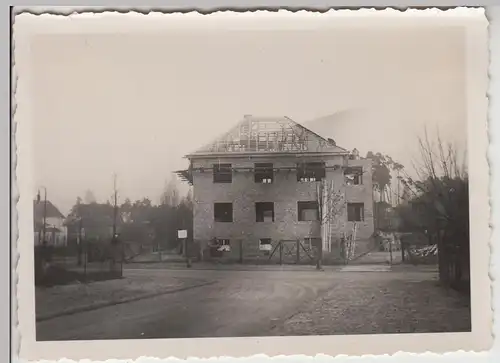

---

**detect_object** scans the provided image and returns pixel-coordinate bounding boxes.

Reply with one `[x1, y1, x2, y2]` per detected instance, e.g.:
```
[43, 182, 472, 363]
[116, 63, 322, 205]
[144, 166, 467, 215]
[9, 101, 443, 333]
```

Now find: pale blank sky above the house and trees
[31, 22, 466, 213]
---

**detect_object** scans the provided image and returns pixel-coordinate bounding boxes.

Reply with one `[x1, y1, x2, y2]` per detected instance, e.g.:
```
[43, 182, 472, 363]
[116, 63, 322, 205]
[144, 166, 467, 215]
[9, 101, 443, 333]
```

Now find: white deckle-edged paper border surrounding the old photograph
[14, 8, 493, 361]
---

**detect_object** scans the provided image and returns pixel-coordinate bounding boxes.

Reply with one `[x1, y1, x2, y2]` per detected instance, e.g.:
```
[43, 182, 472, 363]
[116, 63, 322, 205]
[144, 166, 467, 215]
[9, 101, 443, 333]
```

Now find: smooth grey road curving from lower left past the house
[37, 268, 458, 340]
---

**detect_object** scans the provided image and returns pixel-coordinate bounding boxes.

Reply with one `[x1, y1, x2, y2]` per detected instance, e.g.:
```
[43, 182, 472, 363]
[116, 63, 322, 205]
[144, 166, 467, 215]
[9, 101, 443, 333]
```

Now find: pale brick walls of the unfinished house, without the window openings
[189, 156, 373, 259]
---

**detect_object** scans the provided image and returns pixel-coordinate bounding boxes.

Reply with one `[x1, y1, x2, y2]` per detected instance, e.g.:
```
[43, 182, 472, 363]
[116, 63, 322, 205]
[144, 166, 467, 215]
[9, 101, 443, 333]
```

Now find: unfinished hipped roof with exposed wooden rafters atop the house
[187, 115, 347, 157]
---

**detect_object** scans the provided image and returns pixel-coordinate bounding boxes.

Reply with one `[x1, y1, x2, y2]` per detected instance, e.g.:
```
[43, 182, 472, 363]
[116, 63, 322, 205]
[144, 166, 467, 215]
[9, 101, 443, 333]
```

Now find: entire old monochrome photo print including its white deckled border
[14, 9, 492, 360]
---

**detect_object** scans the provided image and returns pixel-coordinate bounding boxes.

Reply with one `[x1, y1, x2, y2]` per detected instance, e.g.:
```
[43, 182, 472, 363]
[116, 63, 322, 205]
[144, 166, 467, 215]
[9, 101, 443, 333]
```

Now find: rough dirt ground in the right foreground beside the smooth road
[272, 276, 471, 335]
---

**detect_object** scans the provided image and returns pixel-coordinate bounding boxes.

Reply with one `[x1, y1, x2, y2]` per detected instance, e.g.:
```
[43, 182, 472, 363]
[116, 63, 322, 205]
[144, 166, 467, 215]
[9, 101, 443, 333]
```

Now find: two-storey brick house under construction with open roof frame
[177, 116, 374, 262]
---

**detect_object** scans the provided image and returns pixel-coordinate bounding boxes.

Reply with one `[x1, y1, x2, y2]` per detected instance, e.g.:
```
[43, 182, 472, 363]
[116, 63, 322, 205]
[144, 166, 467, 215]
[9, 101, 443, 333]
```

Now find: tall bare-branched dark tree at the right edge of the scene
[403, 130, 469, 288]
